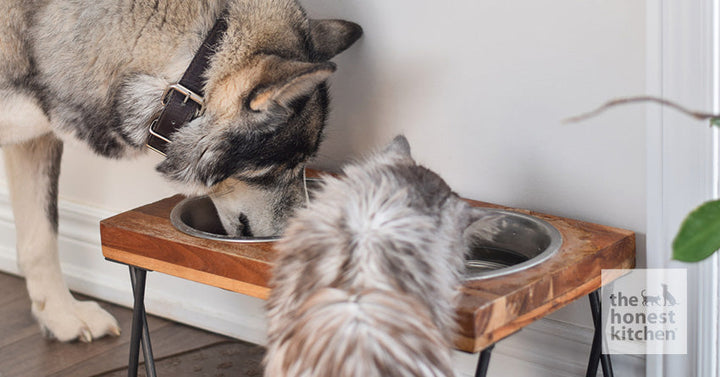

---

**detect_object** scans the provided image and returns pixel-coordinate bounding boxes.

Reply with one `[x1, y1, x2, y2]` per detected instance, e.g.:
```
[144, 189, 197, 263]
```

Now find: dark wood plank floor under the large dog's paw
[0, 273, 263, 377]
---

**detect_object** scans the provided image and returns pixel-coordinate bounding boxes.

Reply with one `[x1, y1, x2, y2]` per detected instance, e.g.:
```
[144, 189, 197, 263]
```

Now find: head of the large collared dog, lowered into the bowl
[158, 6, 362, 236]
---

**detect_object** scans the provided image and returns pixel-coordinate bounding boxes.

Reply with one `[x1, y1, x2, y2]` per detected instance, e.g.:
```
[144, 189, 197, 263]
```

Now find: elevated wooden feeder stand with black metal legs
[100, 196, 635, 377]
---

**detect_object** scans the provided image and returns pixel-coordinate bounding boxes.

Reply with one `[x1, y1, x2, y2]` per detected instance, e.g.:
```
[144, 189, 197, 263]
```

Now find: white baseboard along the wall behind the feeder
[0, 191, 645, 377]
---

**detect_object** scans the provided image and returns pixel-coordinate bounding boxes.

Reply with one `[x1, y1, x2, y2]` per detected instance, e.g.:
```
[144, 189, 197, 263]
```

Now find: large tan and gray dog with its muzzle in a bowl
[0, 0, 362, 341]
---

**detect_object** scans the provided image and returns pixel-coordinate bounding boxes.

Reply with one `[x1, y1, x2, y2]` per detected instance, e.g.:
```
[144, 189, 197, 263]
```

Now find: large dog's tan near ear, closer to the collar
[248, 61, 336, 111]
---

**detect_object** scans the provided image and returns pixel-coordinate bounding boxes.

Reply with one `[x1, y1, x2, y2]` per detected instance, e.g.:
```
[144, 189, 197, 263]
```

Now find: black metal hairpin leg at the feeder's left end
[128, 266, 156, 377]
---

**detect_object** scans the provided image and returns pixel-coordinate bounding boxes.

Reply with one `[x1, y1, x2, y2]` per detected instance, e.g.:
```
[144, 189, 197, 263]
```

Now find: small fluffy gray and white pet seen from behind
[265, 137, 474, 377]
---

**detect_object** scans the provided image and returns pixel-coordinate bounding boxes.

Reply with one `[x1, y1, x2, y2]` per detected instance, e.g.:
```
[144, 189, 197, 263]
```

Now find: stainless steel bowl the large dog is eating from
[170, 178, 321, 243]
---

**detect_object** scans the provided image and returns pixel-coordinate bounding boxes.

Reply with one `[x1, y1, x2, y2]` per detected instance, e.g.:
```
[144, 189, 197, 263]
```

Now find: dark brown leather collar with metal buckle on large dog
[147, 11, 227, 156]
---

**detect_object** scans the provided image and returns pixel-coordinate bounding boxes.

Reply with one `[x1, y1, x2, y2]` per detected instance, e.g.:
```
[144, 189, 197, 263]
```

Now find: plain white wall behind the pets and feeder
[0, 0, 646, 374]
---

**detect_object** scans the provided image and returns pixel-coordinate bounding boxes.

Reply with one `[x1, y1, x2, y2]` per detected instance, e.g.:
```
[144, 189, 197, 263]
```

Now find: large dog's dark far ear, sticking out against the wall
[310, 20, 362, 61]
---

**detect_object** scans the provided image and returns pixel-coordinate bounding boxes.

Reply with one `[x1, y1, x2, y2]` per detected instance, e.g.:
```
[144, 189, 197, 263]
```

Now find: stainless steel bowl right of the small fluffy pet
[463, 208, 562, 280]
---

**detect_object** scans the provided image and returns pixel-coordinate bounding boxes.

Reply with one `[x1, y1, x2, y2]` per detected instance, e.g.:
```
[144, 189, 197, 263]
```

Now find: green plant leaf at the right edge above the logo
[672, 200, 720, 262]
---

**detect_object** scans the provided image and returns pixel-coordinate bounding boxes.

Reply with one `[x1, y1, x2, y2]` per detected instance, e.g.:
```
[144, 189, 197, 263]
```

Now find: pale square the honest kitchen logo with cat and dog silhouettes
[602, 269, 687, 354]
